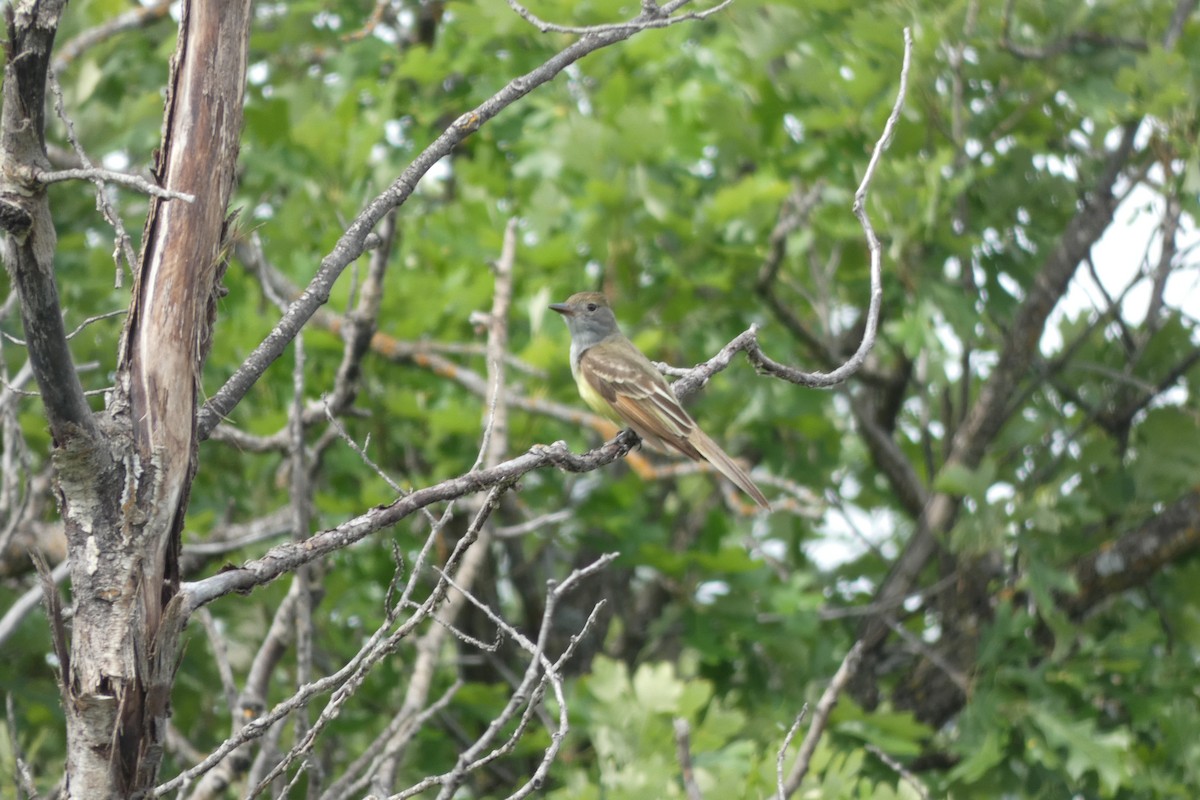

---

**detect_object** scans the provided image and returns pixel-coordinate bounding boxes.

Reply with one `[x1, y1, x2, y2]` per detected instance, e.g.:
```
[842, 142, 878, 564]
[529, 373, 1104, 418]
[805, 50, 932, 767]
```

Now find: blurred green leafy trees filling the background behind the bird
[0, 0, 1200, 799]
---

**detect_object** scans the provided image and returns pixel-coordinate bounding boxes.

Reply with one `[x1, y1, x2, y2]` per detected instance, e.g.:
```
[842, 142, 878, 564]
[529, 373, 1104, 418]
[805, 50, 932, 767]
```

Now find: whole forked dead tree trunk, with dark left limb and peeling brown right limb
[0, 0, 250, 798]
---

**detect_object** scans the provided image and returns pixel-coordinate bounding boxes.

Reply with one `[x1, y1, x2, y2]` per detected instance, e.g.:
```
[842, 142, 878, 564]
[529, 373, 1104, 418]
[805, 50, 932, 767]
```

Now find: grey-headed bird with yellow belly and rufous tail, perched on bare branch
[551, 291, 770, 509]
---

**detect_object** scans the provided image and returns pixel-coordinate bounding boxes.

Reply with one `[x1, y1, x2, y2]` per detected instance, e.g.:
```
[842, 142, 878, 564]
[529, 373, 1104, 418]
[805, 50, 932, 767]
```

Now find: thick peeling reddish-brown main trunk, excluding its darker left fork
[59, 0, 251, 798]
